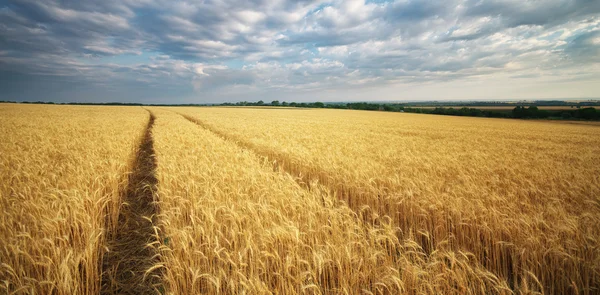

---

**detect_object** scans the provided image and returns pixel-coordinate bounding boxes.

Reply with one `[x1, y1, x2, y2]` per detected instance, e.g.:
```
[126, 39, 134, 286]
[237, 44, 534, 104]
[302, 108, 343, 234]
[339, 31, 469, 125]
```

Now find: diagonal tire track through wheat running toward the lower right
[176, 112, 597, 294]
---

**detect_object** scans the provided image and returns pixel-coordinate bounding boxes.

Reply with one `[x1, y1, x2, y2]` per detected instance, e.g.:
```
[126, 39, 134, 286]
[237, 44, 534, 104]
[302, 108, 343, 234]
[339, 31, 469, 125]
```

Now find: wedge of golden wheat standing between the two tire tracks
[153, 109, 510, 294]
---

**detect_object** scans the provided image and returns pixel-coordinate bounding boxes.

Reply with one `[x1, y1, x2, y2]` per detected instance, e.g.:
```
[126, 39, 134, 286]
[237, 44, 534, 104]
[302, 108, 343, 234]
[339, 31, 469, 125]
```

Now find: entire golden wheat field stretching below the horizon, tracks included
[0, 104, 600, 294]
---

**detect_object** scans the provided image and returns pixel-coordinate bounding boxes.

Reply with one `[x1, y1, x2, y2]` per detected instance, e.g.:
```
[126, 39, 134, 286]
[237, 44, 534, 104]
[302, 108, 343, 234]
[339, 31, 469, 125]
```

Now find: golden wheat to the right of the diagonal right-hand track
[173, 108, 600, 294]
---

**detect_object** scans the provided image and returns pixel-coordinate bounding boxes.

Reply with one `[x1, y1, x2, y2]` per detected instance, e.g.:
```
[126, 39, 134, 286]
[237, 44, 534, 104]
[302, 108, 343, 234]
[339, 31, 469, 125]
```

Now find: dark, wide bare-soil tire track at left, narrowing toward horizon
[100, 111, 163, 294]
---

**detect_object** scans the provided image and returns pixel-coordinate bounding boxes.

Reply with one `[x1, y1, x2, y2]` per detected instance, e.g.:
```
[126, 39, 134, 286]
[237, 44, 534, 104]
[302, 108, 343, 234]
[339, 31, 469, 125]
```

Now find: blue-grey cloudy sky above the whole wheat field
[0, 0, 600, 103]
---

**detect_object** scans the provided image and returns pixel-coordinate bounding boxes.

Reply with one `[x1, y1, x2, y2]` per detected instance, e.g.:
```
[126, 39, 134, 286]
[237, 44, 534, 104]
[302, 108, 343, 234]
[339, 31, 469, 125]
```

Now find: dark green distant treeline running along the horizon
[0, 100, 600, 120]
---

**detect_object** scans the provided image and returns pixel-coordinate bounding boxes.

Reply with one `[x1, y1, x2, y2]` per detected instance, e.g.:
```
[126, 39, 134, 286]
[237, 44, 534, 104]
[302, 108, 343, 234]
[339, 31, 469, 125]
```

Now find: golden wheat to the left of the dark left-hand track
[0, 104, 148, 294]
